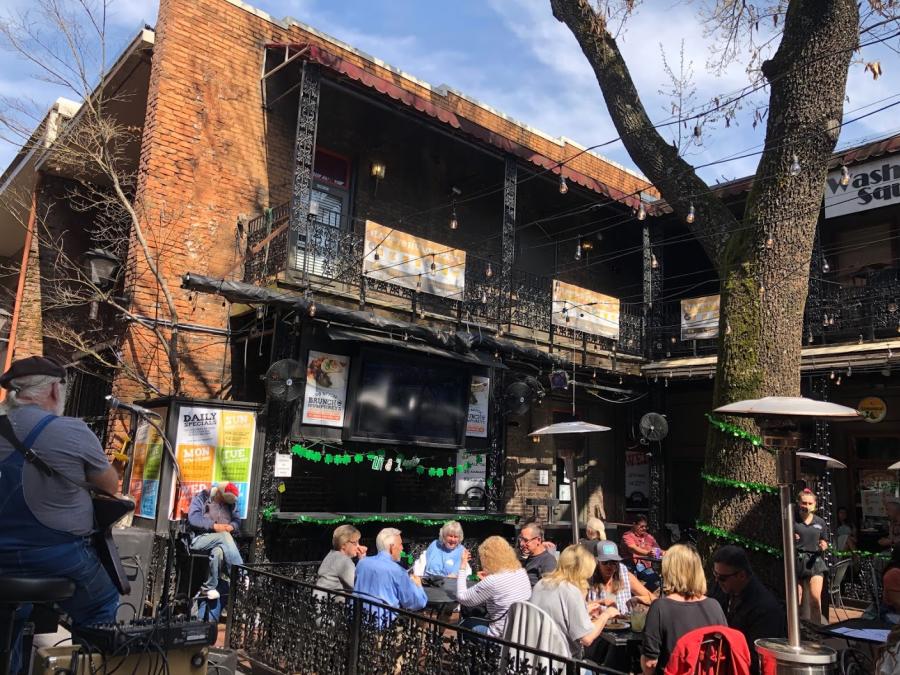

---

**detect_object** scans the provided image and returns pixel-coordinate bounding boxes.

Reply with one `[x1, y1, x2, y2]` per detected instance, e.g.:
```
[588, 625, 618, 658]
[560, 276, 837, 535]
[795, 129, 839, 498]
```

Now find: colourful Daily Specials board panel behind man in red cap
[174, 406, 256, 519]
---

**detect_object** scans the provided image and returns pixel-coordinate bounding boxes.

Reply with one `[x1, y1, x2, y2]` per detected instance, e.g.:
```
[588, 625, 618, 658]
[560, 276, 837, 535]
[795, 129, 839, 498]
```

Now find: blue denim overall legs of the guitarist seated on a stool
[0, 539, 119, 673]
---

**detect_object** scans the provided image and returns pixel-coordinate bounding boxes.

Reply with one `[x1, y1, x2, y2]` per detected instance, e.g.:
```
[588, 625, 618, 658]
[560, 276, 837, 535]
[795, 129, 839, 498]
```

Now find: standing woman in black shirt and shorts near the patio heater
[794, 488, 829, 624]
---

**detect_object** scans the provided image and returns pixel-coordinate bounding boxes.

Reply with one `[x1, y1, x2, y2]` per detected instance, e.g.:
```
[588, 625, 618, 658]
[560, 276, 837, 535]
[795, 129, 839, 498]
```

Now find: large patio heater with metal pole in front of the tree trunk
[714, 396, 861, 675]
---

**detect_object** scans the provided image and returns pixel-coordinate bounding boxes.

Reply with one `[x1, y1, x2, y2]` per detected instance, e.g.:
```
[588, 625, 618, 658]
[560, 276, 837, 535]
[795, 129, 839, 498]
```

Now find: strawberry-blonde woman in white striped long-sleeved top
[456, 536, 531, 637]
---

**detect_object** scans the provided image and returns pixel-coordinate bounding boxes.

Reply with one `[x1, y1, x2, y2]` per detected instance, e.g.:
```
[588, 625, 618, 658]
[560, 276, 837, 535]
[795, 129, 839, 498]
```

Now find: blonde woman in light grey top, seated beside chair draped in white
[531, 544, 619, 659]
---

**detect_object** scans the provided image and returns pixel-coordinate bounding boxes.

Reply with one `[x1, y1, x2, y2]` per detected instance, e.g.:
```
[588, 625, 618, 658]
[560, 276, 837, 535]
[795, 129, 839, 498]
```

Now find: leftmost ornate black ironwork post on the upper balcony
[288, 62, 321, 276]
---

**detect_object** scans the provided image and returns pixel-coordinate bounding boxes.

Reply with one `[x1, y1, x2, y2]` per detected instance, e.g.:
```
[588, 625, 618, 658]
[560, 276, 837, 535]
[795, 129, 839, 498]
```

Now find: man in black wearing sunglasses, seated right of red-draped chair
[710, 546, 787, 675]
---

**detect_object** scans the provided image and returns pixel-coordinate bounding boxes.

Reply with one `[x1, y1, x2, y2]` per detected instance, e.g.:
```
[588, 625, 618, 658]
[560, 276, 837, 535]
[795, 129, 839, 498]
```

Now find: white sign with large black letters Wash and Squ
[825, 155, 900, 218]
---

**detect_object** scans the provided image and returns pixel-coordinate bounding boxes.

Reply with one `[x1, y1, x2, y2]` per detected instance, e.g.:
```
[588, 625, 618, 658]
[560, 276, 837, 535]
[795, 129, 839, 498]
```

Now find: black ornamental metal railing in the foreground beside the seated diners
[227, 563, 617, 675]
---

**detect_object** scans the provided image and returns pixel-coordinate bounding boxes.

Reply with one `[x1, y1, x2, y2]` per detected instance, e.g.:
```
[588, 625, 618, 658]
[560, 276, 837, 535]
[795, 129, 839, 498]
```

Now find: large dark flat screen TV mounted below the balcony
[348, 350, 471, 448]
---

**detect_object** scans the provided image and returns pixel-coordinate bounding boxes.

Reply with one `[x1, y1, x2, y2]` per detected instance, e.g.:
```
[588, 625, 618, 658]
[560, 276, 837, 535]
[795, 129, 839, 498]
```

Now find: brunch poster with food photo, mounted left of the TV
[303, 349, 350, 427]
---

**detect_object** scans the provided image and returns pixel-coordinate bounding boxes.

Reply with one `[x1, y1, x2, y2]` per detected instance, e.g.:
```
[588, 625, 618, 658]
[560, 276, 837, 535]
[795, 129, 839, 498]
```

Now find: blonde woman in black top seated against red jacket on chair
[641, 544, 728, 675]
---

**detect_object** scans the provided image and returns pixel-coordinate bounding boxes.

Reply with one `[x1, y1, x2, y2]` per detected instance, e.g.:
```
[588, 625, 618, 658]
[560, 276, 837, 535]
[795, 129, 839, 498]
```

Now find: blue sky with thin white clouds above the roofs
[0, 0, 900, 182]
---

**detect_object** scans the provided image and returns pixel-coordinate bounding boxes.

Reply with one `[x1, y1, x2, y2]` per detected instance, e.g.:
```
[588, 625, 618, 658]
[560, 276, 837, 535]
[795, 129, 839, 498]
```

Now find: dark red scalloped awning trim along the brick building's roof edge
[267, 44, 638, 209]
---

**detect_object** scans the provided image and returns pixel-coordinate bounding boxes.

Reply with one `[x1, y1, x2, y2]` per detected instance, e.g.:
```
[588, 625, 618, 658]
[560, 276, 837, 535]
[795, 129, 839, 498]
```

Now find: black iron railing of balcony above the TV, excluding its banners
[244, 204, 644, 355]
